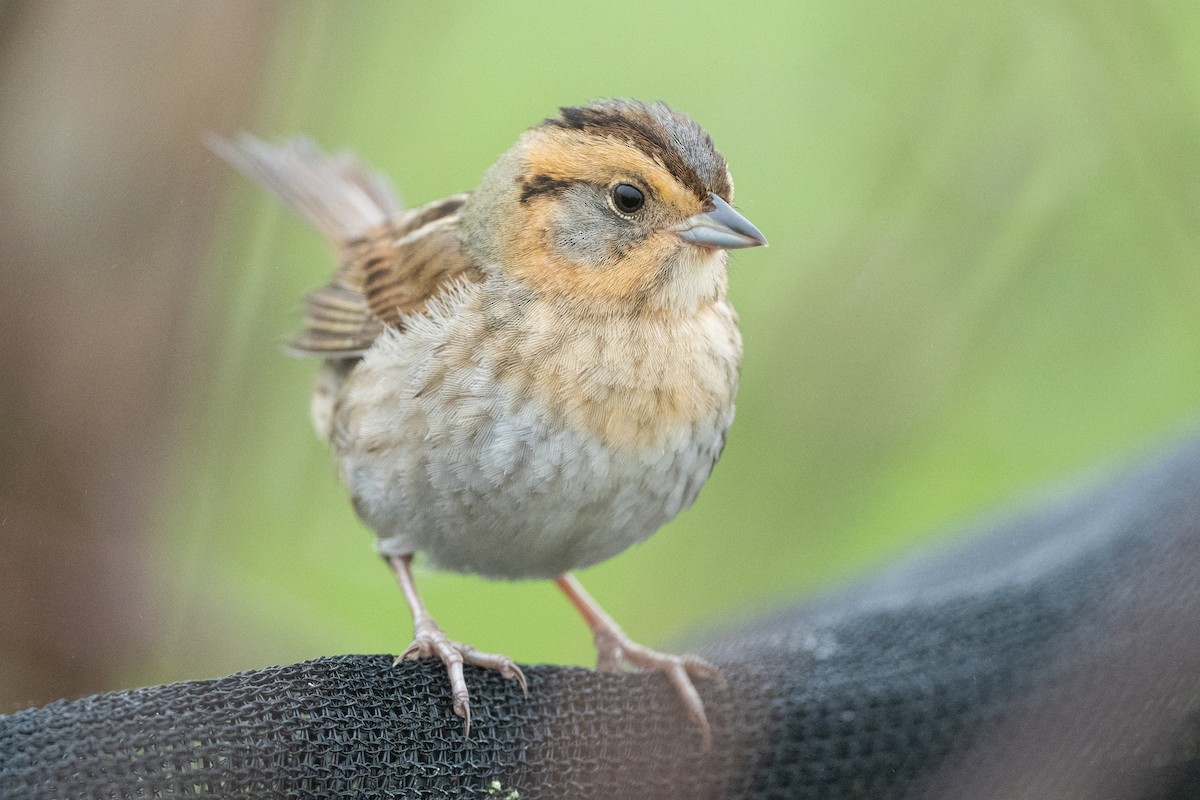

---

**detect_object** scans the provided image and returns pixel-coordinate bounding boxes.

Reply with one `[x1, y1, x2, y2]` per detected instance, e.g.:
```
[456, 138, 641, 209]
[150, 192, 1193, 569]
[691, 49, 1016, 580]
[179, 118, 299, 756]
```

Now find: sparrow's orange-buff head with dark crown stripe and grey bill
[462, 100, 767, 311]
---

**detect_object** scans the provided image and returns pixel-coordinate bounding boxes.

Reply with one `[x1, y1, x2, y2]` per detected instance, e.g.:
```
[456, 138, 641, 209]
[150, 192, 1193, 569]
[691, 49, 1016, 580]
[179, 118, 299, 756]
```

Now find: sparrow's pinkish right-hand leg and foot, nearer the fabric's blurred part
[554, 572, 724, 745]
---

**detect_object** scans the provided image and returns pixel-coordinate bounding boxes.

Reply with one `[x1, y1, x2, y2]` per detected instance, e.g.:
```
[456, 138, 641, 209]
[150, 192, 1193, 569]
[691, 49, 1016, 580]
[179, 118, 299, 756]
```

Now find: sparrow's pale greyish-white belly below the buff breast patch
[335, 345, 733, 578]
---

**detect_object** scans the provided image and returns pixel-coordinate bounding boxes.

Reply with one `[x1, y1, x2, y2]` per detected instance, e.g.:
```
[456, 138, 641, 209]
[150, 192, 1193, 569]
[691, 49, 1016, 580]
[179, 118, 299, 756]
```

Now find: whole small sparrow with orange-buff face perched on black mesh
[214, 100, 767, 741]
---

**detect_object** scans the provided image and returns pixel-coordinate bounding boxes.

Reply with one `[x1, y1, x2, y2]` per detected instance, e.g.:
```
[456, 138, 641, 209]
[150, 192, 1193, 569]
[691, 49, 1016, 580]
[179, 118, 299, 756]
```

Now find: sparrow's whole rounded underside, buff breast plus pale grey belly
[331, 287, 740, 578]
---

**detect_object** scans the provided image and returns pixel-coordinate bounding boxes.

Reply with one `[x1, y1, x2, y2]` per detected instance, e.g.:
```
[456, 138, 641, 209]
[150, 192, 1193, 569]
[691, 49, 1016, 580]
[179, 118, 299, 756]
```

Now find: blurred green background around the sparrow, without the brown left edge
[0, 0, 1200, 710]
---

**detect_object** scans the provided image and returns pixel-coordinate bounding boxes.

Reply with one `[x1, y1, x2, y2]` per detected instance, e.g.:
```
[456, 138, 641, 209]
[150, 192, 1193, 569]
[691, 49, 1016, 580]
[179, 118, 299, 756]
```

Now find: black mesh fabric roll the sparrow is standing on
[0, 439, 1200, 800]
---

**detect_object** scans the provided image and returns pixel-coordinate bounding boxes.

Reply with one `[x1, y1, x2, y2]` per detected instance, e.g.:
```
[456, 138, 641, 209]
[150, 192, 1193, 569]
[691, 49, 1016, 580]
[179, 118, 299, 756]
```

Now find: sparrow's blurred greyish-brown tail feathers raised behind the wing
[208, 133, 403, 243]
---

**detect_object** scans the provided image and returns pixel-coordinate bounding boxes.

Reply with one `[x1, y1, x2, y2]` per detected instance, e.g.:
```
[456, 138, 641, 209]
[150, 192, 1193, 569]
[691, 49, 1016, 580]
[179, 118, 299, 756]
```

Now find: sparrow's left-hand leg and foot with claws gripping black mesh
[385, 554, 529, 736]
